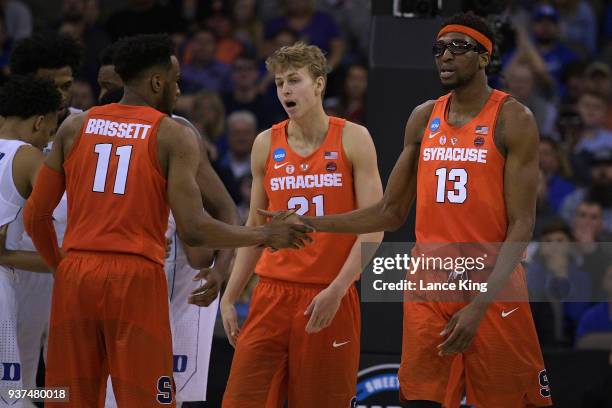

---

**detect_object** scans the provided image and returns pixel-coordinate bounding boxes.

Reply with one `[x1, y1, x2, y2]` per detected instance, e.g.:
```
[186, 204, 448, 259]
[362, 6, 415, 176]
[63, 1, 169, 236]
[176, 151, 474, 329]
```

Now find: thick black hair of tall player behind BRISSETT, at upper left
[10, 33, 83, 75]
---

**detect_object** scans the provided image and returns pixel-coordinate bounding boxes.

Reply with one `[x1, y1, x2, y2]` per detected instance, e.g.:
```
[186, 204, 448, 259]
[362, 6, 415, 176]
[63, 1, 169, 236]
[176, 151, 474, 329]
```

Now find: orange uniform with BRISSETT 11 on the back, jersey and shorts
[46, 104, 174, 407]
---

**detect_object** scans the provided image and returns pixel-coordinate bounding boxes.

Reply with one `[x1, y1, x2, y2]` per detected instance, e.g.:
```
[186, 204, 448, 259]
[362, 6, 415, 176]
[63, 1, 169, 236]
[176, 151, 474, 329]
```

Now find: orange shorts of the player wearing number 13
[398, 268, 552, 408]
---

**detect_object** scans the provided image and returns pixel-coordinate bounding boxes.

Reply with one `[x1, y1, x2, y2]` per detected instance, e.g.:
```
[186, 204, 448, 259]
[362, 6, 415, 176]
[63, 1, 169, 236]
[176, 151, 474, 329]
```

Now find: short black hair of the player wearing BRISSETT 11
[113, 34, 174, 83]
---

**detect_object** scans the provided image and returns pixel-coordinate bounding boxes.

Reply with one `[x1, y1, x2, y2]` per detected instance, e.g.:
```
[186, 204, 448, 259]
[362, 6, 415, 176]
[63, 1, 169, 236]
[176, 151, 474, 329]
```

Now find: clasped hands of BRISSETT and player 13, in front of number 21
[257, 209, 314, 251]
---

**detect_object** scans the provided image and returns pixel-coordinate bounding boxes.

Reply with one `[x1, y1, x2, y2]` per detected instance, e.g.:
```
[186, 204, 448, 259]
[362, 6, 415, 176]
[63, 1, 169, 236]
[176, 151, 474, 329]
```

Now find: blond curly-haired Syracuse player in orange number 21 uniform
[221, 43, 382, 408]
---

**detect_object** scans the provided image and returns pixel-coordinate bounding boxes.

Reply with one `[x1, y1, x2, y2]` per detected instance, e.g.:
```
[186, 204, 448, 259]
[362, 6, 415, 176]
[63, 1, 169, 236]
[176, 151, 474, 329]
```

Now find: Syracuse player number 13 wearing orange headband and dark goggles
[263, 14, 551, 408]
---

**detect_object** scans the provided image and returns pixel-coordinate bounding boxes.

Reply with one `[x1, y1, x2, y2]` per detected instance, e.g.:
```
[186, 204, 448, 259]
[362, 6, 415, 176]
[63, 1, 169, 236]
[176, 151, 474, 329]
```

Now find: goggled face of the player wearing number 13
[434, 33, 481, 89]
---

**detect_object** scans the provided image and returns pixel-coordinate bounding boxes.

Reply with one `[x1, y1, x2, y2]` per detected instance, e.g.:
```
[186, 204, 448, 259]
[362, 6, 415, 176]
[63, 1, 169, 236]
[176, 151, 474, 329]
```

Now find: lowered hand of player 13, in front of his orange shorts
[438, 303, 487, 356]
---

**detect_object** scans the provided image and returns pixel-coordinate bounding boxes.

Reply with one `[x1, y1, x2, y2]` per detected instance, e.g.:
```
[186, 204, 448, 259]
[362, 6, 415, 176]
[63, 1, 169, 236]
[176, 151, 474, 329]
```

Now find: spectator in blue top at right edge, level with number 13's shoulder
[574, 89, 612, 154]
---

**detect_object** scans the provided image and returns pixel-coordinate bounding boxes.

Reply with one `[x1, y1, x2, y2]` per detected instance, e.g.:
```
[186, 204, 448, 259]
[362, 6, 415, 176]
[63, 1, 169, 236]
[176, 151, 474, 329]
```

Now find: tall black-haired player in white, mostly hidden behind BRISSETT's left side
[2, 33, 83, 407]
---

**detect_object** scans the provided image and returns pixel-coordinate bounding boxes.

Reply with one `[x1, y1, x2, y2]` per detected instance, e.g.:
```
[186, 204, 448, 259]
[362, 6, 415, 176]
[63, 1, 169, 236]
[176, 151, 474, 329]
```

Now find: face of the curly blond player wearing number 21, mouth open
[274, 67, 325, 118]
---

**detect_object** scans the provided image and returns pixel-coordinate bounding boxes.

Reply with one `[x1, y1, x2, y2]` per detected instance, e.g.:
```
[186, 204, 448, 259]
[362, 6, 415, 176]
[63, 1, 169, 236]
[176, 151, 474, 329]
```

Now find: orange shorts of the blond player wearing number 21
[223, 278, 361, 408]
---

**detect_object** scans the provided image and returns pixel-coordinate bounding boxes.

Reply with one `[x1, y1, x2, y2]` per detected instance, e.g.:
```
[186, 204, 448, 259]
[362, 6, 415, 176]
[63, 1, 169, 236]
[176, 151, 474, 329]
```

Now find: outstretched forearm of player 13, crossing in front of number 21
[300, 201, 403, 234]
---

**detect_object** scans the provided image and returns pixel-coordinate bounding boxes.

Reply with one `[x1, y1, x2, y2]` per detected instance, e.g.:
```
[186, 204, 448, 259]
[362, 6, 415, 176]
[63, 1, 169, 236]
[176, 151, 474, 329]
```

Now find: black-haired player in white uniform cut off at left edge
[0, 76, 61, 407]
